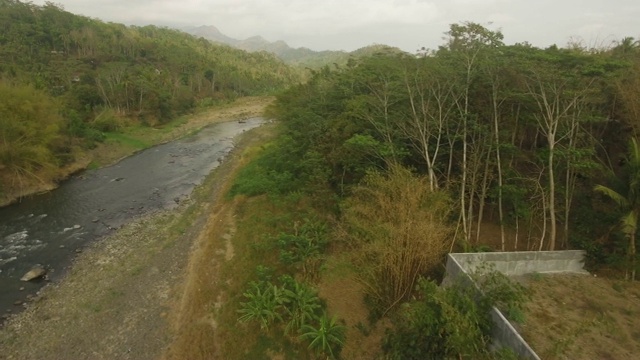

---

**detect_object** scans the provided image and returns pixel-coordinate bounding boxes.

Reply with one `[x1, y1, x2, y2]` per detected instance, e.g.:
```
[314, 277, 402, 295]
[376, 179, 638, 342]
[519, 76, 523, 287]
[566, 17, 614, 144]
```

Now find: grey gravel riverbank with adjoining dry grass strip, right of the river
[0, 100, 268, 360]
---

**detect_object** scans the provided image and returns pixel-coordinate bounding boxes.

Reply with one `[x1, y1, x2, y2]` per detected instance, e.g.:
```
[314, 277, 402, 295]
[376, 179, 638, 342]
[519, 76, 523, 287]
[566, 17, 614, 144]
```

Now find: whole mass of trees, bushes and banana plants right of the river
[220, 23, 640, 359]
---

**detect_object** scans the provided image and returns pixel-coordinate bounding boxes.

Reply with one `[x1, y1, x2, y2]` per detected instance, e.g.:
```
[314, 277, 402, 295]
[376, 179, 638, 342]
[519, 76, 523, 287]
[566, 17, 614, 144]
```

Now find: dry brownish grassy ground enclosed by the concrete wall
[519, 274, 640, 359]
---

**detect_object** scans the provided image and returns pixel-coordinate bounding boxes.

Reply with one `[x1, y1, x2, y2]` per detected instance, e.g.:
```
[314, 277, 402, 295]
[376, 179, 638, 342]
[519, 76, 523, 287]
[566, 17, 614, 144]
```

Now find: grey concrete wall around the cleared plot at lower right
[443, 250, 589, 360]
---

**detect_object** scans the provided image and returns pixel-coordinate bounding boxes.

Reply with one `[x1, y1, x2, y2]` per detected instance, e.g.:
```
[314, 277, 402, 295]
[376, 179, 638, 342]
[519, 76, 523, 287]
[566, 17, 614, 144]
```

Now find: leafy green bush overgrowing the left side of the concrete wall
[384, 269, 528, 360]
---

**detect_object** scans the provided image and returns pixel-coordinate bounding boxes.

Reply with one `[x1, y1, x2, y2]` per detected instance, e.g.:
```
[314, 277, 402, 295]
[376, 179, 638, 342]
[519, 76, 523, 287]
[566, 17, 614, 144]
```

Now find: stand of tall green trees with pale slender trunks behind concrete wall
[262, 23, 640, 256]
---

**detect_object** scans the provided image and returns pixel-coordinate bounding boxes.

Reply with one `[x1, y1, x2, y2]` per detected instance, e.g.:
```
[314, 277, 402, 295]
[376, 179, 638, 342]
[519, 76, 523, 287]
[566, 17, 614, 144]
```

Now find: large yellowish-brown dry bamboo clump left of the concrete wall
[344, 166, 451, 315]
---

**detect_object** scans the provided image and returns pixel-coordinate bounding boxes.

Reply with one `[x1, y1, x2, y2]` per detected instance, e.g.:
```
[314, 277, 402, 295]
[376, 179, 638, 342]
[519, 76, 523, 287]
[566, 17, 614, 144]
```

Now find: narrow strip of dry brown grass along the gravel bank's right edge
[164, 126, 272, 359]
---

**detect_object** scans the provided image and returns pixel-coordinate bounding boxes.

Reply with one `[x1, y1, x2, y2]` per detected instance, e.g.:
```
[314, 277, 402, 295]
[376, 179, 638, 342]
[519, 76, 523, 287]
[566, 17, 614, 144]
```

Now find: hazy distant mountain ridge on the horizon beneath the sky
[183, 25, 402, 68]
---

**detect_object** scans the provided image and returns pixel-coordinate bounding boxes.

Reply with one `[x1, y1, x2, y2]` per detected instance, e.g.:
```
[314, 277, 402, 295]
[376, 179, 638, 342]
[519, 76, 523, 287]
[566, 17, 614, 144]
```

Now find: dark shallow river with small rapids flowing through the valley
[0, 118, 263, 316]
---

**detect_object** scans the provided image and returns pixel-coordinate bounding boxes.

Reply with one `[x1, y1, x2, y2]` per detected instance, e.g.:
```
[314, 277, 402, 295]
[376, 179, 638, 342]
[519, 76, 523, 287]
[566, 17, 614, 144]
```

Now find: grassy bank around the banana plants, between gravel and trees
[160, 122, 385, 359]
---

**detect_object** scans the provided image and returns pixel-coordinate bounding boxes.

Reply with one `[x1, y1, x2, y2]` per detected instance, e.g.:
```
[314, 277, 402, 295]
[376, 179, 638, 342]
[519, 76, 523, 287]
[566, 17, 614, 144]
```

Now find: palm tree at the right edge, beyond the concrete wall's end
[594, 138, 640, 280]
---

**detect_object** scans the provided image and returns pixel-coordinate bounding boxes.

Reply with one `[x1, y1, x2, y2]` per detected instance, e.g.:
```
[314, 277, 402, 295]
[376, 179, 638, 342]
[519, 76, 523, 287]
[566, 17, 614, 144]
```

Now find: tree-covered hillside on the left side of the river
[0, 0, 300, 200]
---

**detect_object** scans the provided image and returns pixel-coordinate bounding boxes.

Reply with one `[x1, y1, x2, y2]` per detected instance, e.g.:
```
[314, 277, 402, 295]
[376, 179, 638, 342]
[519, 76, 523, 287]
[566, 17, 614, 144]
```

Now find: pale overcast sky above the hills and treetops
[33, 0, 640, 52]
